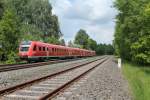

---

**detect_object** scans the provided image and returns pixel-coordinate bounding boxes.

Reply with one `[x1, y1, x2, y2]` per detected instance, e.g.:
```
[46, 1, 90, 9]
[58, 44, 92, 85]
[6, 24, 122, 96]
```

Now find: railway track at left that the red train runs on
[0, 59, 86, 72]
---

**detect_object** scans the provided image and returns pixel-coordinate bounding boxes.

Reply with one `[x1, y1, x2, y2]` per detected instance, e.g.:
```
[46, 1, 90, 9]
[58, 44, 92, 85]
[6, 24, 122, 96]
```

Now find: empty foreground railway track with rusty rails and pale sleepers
[0, 58, 107, 100]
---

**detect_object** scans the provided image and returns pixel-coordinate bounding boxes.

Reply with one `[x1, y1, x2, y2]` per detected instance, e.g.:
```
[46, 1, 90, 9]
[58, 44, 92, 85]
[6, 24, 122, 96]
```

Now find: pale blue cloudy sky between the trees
[50, 0, 116, 44]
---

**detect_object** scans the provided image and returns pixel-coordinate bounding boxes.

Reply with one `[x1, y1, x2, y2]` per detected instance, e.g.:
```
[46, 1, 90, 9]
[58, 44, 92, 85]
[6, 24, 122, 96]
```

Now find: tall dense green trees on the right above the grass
[114, 0, 150, 64]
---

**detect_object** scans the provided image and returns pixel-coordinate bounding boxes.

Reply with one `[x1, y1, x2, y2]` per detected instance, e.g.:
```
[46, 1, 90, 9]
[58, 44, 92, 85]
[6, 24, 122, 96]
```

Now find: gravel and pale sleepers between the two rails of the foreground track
[0, 61, 104, 100]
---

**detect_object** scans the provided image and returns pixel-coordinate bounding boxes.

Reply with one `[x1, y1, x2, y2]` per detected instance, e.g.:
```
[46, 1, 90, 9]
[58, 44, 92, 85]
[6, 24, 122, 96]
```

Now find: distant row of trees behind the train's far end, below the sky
[68, 29, 114, 55]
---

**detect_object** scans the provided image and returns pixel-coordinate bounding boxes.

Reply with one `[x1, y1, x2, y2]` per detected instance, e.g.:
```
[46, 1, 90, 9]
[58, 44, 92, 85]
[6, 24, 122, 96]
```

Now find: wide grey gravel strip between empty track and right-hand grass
[53, 57, 131, 100]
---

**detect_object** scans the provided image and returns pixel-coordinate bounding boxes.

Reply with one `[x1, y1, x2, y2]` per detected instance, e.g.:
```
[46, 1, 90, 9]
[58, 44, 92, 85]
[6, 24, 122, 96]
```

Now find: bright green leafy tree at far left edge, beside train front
[0, 9, 20, 60]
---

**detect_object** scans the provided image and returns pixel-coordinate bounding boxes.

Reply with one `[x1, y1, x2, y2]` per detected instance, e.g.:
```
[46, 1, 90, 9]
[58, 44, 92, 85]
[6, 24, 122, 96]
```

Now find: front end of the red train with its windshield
[19, 41, 32, 61]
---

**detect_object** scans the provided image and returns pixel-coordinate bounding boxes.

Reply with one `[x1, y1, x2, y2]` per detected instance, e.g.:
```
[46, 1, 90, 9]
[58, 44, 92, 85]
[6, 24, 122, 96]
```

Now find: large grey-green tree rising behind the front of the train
[7, 0, 62, 42]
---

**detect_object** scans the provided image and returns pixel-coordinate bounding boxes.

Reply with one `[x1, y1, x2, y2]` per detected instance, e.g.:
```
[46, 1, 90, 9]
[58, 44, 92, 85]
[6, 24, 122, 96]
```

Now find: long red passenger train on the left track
[19, 41, 95, 61]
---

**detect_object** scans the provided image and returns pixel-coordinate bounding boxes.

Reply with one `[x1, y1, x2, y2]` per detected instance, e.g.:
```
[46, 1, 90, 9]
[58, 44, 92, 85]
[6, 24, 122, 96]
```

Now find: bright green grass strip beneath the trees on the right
[122, 62, 150, 100]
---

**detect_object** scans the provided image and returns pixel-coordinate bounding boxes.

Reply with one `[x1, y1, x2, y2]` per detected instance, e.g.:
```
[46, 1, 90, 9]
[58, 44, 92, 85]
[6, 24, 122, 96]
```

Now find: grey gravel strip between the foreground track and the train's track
[0, 57, 101, 89]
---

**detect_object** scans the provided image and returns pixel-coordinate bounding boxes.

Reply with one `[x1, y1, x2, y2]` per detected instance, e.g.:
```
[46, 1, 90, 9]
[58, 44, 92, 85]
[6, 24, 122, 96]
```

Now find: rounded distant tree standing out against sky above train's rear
[74, 29, 89, 49]
